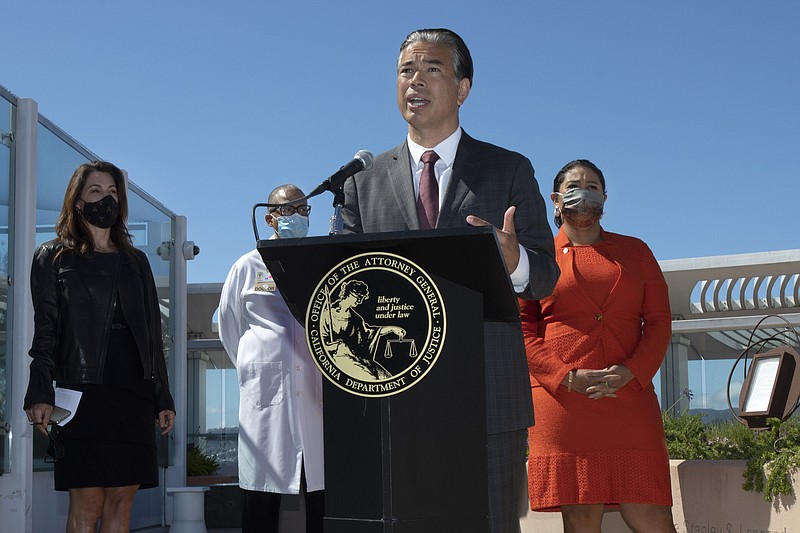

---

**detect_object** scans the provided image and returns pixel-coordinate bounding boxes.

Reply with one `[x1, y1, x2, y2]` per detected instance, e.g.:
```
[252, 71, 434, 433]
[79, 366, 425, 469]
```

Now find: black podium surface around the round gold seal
[258, 228, 519, 533]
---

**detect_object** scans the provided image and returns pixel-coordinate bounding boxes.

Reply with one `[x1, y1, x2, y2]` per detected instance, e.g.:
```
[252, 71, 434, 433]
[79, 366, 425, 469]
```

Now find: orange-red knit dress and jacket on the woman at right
[520, 230, 672, 511]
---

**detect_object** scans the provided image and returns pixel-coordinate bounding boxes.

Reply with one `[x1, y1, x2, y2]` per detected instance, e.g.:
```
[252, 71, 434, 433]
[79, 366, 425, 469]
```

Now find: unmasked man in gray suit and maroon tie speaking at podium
[343, 29, 559, 533]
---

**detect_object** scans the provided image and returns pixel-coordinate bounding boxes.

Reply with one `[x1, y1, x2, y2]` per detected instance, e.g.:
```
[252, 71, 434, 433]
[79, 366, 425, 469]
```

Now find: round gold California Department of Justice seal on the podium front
[306, 252, 446, 398]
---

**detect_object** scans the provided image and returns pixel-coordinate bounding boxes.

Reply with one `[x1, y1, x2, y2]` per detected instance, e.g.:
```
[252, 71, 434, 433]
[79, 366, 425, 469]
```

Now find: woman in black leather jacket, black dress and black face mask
[25, 162, 175, 533]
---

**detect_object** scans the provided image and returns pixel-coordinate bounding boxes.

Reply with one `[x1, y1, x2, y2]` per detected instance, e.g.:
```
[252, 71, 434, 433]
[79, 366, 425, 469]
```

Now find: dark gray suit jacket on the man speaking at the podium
[343, 132, 559, 434]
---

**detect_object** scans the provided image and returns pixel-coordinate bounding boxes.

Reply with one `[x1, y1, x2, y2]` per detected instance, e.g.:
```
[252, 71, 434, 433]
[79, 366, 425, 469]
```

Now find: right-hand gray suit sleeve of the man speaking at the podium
[510, 157, 559, 300]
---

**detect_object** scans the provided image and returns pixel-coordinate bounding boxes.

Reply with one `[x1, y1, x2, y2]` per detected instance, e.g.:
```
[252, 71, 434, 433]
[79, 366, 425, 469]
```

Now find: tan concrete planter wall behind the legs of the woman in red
[520, 461, 800, 533]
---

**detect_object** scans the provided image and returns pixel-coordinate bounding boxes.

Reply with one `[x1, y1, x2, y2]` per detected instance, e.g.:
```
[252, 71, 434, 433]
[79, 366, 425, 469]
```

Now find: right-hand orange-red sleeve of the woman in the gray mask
[623, 243, 672, 390]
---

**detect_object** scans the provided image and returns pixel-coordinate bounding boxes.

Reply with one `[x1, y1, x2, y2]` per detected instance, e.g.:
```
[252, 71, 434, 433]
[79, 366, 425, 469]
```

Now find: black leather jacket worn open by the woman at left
[24, 240, 175, 412]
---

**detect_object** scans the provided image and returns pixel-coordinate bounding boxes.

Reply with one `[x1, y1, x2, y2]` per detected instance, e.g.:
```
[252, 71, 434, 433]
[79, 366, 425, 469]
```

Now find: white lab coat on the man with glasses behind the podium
[219, 250, 324, 494]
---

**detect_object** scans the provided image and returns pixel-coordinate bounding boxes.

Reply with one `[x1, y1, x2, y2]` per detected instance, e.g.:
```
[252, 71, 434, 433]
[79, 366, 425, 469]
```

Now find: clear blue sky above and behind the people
[0, 0, 800, 282]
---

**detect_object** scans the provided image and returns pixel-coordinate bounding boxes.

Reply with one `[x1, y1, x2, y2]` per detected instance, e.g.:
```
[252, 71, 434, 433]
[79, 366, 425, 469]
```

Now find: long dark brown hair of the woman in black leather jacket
[56, 161, 133, 258]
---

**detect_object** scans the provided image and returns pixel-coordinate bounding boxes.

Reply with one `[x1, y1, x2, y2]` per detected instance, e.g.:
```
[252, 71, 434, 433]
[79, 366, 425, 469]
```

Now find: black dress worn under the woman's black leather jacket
[54, 253, 158, 491]
